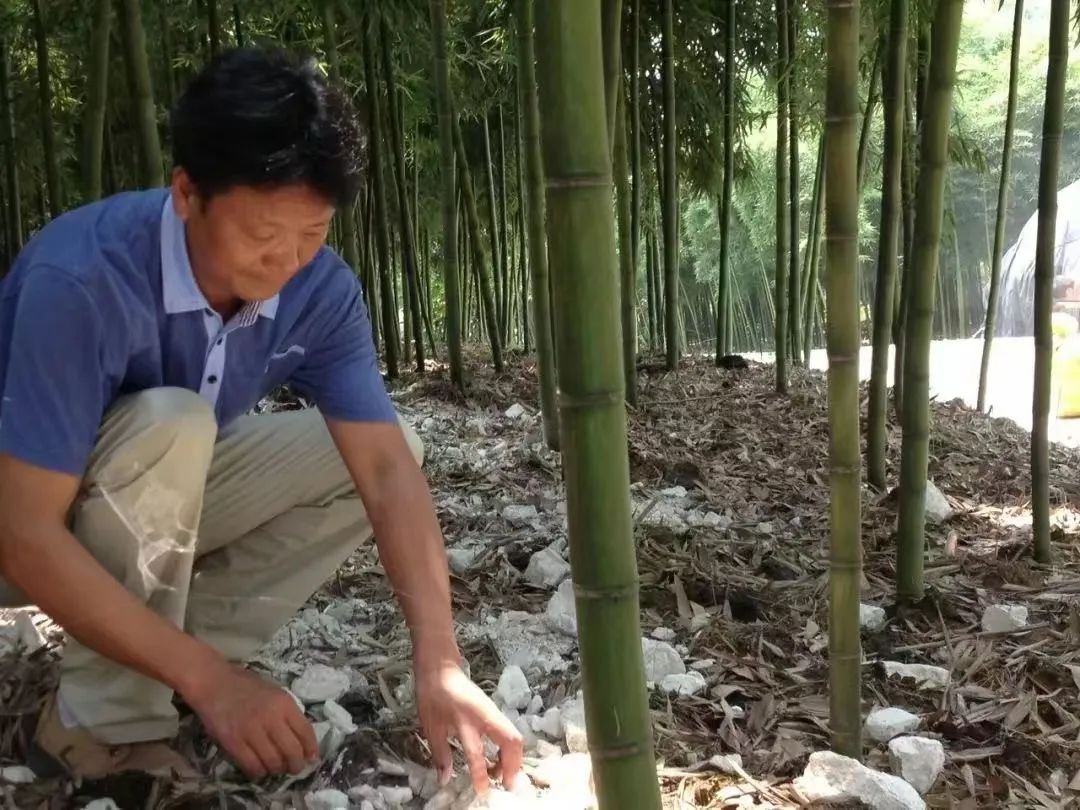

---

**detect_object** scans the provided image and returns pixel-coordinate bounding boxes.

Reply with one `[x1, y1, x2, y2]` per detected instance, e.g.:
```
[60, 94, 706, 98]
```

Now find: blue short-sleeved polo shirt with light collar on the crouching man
[0, 189, 396, 475]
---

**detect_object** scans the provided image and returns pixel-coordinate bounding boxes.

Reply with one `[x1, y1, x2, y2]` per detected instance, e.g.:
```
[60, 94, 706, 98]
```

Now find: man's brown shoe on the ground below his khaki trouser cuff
[30, 692, 199, 780]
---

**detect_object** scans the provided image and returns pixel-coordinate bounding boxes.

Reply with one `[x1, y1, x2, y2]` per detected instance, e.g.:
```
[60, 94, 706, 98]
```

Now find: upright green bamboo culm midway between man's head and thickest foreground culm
[428, 0, 464, 391]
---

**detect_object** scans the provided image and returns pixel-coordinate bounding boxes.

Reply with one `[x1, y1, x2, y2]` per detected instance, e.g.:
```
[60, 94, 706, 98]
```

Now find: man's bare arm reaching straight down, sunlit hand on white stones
[326, 419, 522, 792]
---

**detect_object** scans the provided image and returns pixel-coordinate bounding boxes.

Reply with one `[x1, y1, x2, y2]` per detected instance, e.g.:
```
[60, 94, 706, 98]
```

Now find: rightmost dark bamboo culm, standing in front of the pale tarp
[1031, 0, 1069, 563]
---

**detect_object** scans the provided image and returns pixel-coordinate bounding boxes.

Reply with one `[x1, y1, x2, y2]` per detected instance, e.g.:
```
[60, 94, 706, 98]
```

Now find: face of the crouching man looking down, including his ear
[173, 168, 334, 302]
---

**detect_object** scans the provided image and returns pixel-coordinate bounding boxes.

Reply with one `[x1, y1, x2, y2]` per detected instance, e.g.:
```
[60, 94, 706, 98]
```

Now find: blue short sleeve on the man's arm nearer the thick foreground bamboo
[291, 271, 397, 422]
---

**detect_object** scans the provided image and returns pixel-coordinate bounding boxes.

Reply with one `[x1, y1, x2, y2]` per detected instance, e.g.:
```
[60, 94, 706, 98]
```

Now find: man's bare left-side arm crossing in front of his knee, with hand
[0, 454, 318, 777]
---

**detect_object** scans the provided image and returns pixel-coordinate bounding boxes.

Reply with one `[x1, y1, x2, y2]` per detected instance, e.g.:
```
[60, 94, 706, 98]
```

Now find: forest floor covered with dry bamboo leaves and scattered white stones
[0, 349, 1080, 810]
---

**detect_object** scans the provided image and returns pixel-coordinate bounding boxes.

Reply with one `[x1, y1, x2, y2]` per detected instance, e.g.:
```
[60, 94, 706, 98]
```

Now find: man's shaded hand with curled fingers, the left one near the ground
[185, 664, 319, 779]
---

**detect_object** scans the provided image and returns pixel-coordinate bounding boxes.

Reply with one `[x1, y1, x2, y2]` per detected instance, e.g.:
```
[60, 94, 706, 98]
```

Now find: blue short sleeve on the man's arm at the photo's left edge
[0, 267, 109, 476]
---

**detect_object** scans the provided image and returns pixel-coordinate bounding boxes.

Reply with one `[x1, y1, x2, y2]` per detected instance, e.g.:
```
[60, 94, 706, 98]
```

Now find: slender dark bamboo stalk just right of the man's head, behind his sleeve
[361, 18, 399, 379]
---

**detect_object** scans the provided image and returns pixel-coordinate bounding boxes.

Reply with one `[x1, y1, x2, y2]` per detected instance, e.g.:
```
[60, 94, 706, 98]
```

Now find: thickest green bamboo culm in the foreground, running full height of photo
[537, 0, 661, 810]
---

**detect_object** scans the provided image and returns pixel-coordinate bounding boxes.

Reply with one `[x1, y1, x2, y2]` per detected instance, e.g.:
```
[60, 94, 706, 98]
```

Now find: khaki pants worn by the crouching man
[0, 388, 423, 744]
